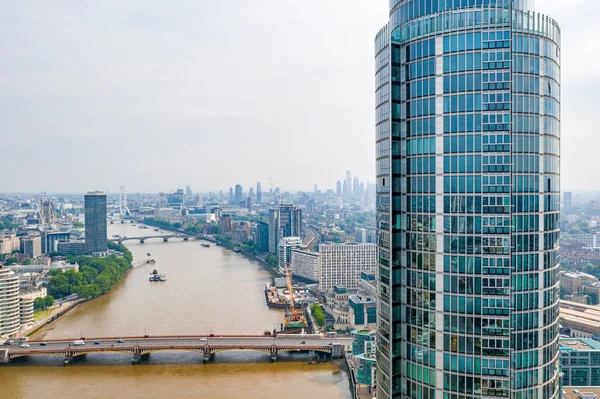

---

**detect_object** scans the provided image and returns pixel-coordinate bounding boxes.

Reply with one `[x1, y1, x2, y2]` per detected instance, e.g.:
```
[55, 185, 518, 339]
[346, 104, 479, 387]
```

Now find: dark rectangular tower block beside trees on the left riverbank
[84, 191, 107, 253]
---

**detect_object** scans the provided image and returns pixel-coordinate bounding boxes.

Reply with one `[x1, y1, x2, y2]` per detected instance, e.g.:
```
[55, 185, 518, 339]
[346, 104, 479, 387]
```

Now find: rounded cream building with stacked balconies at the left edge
[0, 266, 21, 337]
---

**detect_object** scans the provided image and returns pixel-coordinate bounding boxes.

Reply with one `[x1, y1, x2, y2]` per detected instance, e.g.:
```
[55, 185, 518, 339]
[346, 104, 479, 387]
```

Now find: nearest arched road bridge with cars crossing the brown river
[0, 334, 352, 365]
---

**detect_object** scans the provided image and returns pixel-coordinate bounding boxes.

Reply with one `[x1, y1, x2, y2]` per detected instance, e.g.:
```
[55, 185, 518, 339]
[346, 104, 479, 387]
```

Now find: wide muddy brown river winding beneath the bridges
[0, 224, 351, 399]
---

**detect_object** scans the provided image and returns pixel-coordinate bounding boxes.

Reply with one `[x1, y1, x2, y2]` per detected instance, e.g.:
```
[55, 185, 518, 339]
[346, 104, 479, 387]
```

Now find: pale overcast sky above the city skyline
[0, 0, 600, 192]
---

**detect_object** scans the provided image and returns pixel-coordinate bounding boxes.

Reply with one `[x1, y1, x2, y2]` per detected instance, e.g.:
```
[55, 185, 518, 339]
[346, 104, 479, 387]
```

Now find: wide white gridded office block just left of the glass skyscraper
[317, 243, 377, 292]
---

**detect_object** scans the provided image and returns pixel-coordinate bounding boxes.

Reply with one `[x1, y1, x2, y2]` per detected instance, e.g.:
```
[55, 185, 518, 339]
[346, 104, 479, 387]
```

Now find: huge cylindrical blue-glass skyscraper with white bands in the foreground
[375, 0, 560, 399]
